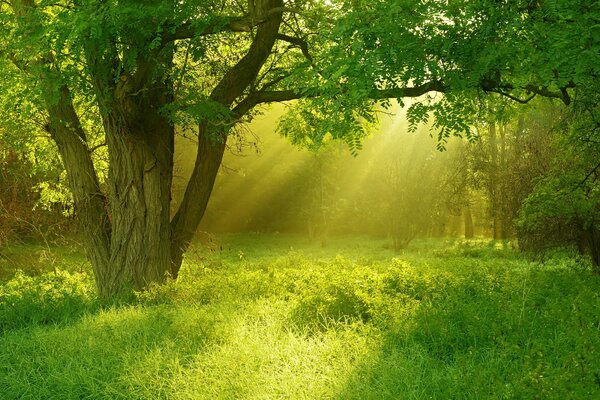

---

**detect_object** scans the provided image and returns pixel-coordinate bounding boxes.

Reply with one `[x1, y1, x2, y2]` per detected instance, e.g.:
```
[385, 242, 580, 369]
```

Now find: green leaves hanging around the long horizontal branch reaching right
[284, 0, 600, 148]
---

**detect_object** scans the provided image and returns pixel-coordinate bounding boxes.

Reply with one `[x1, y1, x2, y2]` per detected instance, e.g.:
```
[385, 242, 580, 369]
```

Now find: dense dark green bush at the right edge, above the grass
[519, 103, 600, 268]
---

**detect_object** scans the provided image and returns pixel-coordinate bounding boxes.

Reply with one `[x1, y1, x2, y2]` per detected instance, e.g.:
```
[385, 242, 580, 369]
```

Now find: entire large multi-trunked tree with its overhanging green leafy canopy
[0, 0, 600, 296]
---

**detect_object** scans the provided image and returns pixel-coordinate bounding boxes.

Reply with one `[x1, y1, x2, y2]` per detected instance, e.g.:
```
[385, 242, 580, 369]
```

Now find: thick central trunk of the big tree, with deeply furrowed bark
[76, 2, 175, 297]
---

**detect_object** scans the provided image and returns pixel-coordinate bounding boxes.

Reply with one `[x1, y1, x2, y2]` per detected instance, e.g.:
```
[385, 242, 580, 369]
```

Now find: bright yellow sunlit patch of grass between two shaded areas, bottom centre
[164, 302, 377, 399]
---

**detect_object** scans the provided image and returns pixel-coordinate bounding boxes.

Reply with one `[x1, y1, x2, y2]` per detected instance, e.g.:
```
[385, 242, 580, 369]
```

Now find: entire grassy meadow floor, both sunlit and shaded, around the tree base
[0, 235, 600, 400]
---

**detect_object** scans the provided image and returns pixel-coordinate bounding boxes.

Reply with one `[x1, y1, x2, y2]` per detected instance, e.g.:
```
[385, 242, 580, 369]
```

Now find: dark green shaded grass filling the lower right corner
[337, 268, 600, 400]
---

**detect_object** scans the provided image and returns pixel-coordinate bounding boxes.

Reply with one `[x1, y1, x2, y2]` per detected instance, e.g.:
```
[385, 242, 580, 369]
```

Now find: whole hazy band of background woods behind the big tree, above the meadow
[0, 99, 600, 264]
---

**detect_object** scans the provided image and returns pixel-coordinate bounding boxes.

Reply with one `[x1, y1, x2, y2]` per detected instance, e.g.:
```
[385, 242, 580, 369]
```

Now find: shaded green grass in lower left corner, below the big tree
[0, 306, 232, 399]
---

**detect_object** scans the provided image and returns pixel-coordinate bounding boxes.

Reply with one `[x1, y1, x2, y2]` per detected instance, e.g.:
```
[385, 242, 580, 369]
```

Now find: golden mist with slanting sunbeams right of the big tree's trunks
[173, 107, 482, 248]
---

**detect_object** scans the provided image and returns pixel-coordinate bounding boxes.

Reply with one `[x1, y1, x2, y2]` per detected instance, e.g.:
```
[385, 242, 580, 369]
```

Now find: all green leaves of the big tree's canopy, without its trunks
[3, 0, 600, 166]
